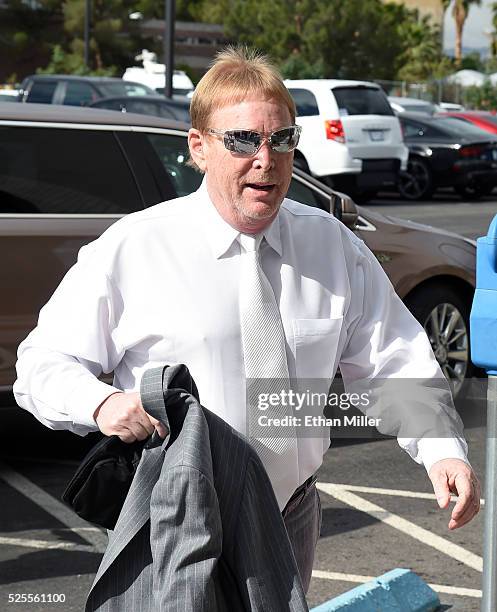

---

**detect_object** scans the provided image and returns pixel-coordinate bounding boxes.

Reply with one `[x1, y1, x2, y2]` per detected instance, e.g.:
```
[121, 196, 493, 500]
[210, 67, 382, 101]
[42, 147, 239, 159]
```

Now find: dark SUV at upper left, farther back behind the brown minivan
[20, 74, 159, 106]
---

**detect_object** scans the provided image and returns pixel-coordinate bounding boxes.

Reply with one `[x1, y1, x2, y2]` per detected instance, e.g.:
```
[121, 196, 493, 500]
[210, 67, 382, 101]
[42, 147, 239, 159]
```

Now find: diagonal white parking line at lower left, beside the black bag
[0, 461, 107, 553]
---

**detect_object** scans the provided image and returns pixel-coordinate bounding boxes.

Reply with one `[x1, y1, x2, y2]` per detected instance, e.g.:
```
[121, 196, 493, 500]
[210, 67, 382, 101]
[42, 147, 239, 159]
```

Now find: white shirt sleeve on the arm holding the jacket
[13, 241, 123, 435]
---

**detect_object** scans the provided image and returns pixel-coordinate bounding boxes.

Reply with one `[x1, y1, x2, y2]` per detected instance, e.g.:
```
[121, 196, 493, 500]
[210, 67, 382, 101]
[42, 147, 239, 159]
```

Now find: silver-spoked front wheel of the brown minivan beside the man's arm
[406, 286, 474, 399]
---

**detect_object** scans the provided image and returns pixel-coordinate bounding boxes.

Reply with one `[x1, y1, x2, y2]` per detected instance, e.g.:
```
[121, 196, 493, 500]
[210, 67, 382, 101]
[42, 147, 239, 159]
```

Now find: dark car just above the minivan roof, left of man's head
[89, 96, 190, 123]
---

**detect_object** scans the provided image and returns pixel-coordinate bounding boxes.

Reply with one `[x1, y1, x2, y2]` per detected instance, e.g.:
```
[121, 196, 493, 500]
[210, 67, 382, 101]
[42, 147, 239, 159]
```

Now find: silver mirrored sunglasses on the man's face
[207, 125, 302, 157]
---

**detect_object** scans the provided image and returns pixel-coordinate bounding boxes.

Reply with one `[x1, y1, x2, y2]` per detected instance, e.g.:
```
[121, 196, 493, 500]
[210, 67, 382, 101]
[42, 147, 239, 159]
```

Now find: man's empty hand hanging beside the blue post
[428, 459, 480, 529]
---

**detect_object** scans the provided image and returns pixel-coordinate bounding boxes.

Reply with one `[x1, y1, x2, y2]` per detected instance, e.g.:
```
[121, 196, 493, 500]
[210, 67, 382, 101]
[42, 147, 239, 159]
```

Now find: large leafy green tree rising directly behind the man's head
[202, 0, 406, 79]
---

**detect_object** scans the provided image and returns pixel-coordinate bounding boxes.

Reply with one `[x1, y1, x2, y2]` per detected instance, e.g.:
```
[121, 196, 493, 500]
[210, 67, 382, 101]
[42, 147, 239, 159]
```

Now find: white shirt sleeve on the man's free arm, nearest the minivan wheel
[340, 235, 467, 471]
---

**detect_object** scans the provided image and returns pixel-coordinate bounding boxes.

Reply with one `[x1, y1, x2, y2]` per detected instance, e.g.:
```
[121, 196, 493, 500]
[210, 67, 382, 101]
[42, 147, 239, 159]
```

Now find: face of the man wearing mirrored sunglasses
[188, 99, 293, 233]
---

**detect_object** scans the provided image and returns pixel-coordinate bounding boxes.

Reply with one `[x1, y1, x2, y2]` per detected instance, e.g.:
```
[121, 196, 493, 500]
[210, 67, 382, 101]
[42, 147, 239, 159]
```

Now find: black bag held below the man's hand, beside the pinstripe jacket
[62, 436, 149, 529]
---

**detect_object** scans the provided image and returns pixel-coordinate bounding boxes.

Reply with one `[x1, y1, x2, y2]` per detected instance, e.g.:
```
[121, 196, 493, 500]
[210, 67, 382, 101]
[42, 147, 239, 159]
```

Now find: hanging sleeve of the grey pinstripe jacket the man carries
[150, 466, 224, 612]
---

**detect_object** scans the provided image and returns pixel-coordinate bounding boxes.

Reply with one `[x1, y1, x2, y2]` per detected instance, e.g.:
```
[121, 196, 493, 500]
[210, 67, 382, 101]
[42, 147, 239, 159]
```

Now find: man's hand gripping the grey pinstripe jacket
[93, 393, 169, 444]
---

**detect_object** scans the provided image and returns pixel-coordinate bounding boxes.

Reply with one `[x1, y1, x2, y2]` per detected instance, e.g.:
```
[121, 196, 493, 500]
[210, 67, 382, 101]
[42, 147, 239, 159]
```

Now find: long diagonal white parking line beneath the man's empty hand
[316, 482, 483, 572]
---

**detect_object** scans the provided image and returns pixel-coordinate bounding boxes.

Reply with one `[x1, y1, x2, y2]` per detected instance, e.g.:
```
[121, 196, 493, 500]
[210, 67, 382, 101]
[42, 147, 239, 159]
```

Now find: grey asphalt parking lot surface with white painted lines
[0, 194, 497, 612]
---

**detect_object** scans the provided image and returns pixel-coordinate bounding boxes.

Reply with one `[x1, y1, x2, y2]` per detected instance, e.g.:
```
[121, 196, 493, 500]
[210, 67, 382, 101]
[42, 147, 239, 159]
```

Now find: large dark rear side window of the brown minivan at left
[0, 127, 142, 214]
